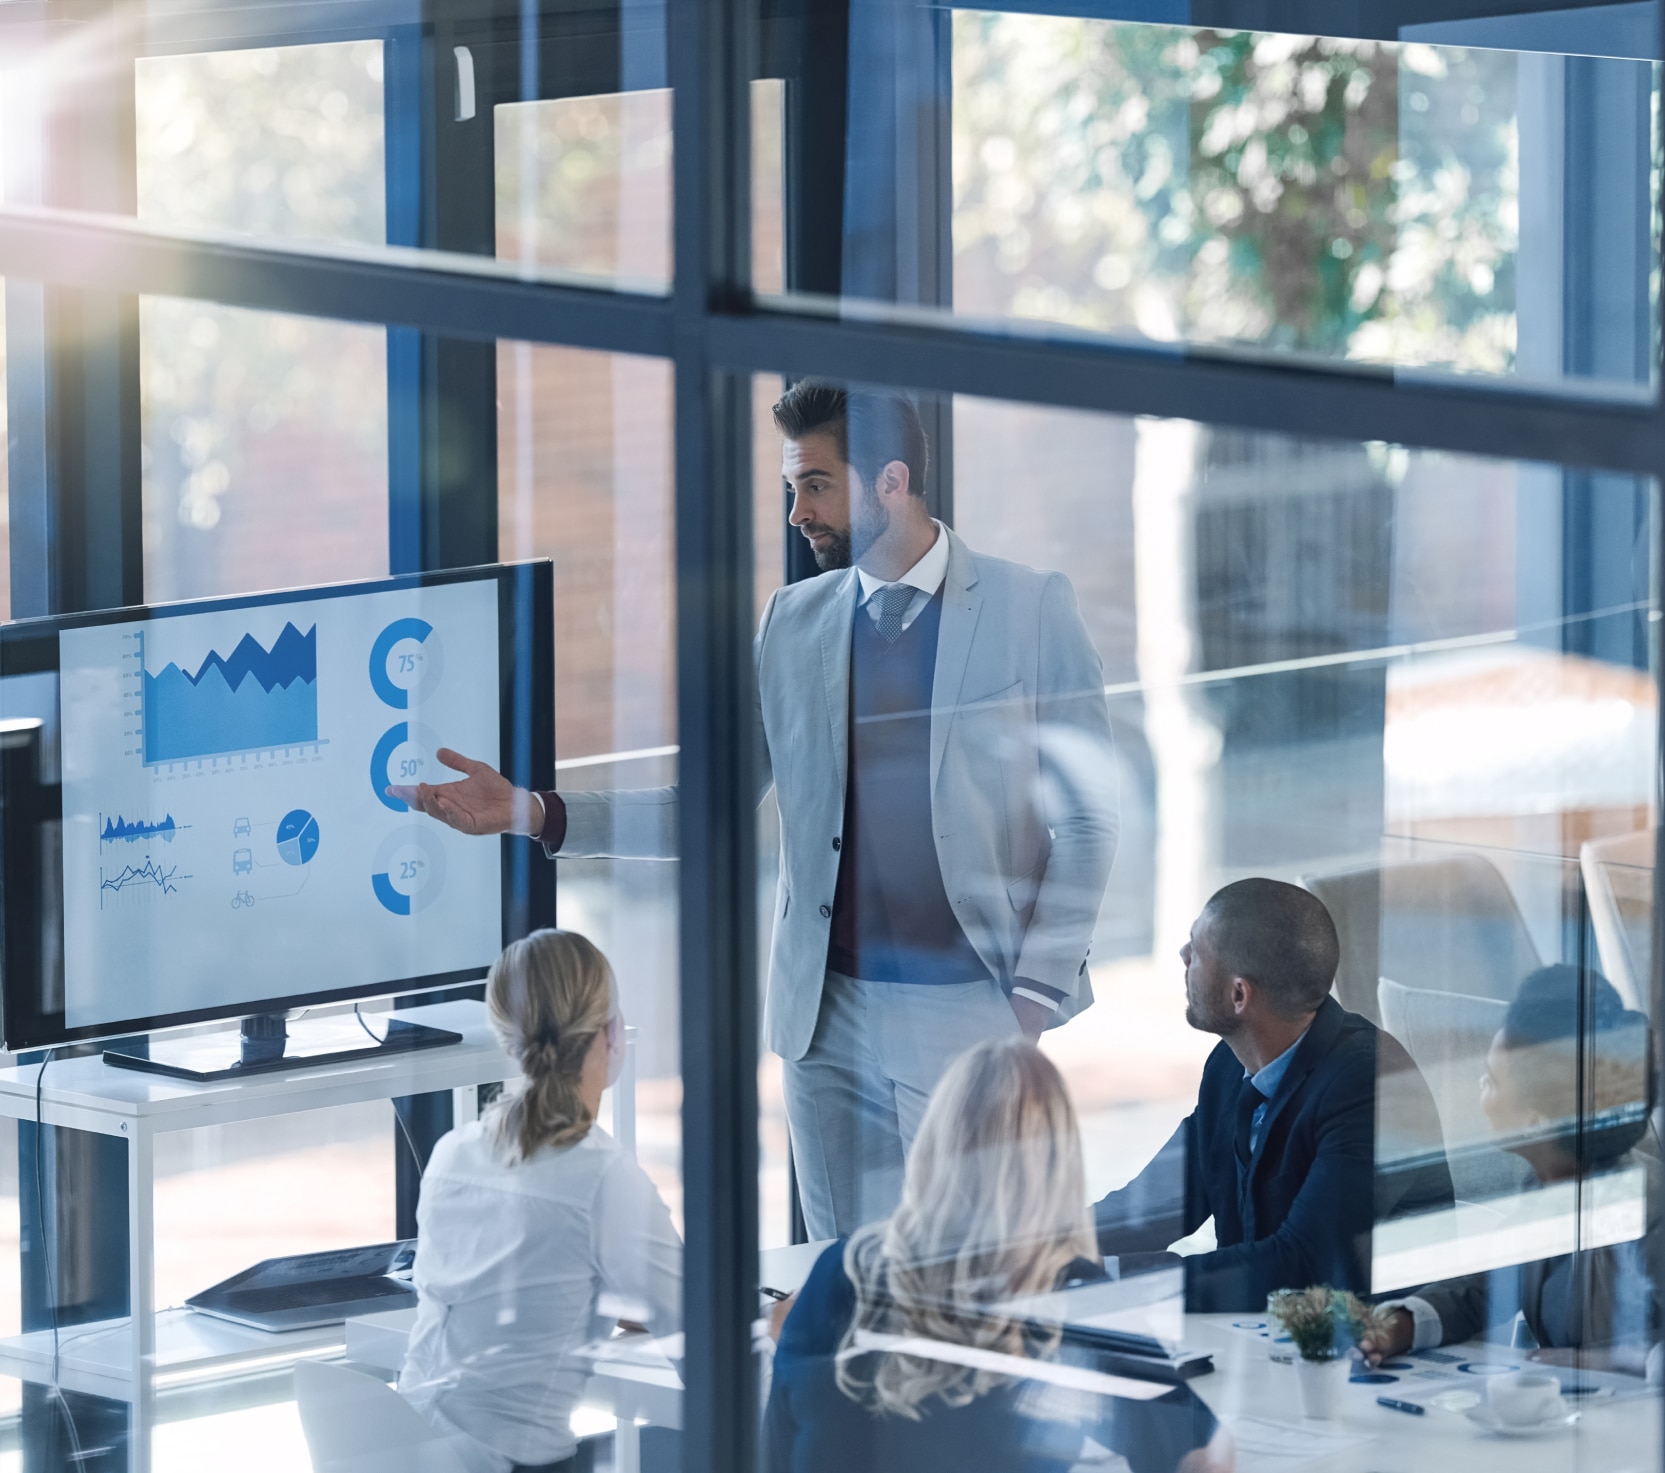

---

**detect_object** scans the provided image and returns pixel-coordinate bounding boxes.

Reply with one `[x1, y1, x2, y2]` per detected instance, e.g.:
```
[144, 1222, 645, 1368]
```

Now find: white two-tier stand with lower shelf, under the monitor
[0, 1002, 526, 1473]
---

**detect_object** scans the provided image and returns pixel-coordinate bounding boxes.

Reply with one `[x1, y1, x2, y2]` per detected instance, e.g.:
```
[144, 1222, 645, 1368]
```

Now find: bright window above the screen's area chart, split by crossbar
[135, 42, 388, 601]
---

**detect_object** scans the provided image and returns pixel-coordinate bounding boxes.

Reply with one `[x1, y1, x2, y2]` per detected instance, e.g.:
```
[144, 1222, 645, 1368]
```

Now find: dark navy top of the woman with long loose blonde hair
[764, 1243, 1215, 1473]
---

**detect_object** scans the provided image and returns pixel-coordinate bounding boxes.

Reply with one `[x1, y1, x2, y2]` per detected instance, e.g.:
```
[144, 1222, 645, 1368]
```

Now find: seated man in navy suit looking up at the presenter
[1094, 879, 1452, 1313]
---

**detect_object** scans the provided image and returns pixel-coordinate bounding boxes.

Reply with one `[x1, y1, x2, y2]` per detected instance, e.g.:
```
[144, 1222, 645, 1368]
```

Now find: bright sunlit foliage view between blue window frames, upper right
[954, 22, 1520, 373]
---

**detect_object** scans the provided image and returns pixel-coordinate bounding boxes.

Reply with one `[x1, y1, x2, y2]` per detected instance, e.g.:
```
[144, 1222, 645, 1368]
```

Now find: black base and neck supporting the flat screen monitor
[103, 1012, 463, 1080]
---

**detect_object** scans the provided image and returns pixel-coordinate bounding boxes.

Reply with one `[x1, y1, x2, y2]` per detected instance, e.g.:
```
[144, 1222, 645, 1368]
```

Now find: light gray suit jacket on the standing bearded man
[561, 531, 1117, 1059]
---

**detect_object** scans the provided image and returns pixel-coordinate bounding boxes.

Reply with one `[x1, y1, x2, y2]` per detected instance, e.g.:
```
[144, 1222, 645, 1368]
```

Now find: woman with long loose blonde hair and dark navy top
[766, 1039, 1219, 1473]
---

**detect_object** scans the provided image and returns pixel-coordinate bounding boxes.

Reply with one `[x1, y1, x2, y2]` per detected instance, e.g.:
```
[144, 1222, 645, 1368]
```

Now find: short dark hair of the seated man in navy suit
[1202, 879, 1342, 1019]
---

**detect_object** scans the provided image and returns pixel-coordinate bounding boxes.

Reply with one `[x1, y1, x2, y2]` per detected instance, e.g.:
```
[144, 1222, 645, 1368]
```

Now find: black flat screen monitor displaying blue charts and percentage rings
[0, 563, 554, 1050]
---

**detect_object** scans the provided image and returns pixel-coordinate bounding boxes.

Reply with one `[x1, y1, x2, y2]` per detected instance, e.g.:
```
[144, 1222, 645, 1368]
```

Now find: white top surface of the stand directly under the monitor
[0, 1000, 519, 1135]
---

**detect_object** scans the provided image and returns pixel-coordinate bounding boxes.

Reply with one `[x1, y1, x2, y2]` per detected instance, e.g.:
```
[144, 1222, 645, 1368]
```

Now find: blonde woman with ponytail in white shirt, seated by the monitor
[400, 930, 683, 1473]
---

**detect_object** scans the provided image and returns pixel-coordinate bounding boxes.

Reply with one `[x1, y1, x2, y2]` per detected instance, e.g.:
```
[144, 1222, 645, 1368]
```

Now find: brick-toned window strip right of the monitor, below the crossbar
[498, 343, 683, 1223]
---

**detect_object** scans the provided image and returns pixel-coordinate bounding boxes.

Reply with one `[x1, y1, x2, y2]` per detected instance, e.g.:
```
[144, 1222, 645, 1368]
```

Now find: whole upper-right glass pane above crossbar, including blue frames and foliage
[773, 3, 1658, 393]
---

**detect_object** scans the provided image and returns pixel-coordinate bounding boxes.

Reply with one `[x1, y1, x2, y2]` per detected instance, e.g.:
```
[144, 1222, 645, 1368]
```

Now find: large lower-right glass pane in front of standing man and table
[758, 372, 1660, 1468]
